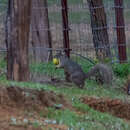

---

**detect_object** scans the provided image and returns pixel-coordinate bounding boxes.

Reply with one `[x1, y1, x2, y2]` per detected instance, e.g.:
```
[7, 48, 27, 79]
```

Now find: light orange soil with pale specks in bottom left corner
[0, 106, 68, 130]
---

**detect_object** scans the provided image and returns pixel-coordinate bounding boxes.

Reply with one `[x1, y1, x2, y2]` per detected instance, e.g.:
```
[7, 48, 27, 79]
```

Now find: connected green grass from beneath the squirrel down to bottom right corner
[0, 76, 130, 130]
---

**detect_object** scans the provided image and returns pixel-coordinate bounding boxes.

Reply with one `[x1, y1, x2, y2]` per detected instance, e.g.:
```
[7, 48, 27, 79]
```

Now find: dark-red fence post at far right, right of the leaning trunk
[114, 0, 127, 63]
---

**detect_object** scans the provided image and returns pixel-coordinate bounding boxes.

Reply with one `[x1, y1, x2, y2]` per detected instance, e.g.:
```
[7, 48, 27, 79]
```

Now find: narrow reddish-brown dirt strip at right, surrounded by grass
[81, 97, 130, 120]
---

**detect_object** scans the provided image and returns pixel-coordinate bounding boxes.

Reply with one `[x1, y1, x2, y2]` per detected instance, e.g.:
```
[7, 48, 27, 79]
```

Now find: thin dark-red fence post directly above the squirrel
[61, 0, 70, 57]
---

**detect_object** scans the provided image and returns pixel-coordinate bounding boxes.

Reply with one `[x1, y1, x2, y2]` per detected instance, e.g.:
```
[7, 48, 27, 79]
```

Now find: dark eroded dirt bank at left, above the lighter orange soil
[0, 86, 70, 109]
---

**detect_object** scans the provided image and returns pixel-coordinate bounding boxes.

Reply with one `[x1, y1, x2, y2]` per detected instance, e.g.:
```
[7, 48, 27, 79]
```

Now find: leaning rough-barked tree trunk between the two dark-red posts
[87, 0, 110, 59]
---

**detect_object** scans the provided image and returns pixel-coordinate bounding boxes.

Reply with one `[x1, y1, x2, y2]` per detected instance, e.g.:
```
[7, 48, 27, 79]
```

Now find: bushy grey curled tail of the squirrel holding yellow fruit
[86, 64, 113, 84]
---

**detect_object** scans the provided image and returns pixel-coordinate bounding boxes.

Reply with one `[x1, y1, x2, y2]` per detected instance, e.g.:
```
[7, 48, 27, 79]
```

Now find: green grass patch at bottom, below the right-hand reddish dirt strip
[47, 102, 130, 130]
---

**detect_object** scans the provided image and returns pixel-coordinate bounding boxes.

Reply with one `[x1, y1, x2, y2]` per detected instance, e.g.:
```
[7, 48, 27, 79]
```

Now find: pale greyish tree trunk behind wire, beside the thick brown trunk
[31, 0, 52, 61]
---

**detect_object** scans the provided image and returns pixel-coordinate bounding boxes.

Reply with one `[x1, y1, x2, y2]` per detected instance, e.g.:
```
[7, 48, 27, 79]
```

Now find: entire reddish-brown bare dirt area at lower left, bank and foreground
[0, 86, 71, 130]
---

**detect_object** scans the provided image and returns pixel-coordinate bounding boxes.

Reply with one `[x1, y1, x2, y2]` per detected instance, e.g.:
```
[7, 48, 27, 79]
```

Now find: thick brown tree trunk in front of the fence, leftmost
[6, 0, 31, 81]
